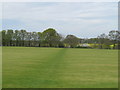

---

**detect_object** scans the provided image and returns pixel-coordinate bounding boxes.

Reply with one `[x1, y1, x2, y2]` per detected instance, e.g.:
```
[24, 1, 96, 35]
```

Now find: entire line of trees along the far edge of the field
[0, 28, 120, 49]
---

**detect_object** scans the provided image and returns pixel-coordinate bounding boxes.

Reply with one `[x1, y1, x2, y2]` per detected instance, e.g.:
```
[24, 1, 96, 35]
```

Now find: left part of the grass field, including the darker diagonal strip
[3, 47, 65, 88]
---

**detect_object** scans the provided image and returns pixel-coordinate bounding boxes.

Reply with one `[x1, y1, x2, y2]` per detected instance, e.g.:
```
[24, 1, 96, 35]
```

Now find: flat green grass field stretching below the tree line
[3, 47, 118, 88]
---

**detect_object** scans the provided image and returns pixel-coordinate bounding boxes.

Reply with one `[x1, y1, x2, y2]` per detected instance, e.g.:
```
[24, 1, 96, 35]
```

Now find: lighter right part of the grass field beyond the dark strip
[56, 49, 118, 88]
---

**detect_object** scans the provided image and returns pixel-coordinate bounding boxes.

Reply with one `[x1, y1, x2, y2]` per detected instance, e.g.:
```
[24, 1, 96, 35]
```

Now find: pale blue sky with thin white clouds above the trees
[1, 2, 118, 38]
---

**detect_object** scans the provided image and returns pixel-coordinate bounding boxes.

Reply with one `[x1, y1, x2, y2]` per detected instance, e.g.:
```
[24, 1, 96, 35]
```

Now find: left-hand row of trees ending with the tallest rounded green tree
[1, 28, 67, 47]
